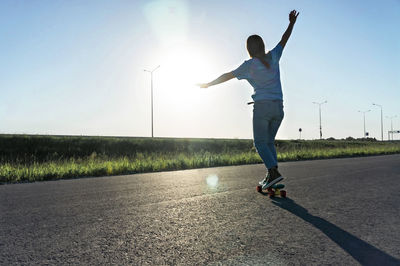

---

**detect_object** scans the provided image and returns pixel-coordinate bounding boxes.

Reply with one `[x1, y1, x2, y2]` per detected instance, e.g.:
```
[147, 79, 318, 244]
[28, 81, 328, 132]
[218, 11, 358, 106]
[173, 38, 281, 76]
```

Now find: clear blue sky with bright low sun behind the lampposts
[0, 0, 400, 139]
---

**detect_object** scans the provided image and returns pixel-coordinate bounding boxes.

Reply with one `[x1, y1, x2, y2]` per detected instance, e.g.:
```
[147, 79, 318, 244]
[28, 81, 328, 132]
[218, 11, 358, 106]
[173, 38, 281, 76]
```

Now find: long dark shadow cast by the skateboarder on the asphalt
[272, 198, 400, 265]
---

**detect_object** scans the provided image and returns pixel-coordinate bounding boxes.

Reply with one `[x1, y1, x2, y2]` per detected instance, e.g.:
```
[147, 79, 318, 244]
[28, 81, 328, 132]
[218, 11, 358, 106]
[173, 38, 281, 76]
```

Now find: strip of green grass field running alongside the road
[0, 135, 400, 183]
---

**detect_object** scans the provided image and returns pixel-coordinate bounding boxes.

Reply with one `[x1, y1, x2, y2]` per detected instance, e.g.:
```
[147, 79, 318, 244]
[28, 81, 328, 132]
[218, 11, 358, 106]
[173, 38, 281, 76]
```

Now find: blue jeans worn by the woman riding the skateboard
[253, 100, 284, 169]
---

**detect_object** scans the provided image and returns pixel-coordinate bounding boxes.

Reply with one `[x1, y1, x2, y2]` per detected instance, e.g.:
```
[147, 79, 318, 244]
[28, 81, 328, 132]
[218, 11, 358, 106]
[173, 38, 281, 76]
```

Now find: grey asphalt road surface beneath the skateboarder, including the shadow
[0, 155, 400, 265]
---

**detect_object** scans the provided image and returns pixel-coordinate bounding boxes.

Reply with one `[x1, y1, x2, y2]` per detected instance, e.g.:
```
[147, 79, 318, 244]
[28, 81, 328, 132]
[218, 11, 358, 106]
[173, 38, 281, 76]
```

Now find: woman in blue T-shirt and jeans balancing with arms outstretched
[199, 10, 299, 189]
